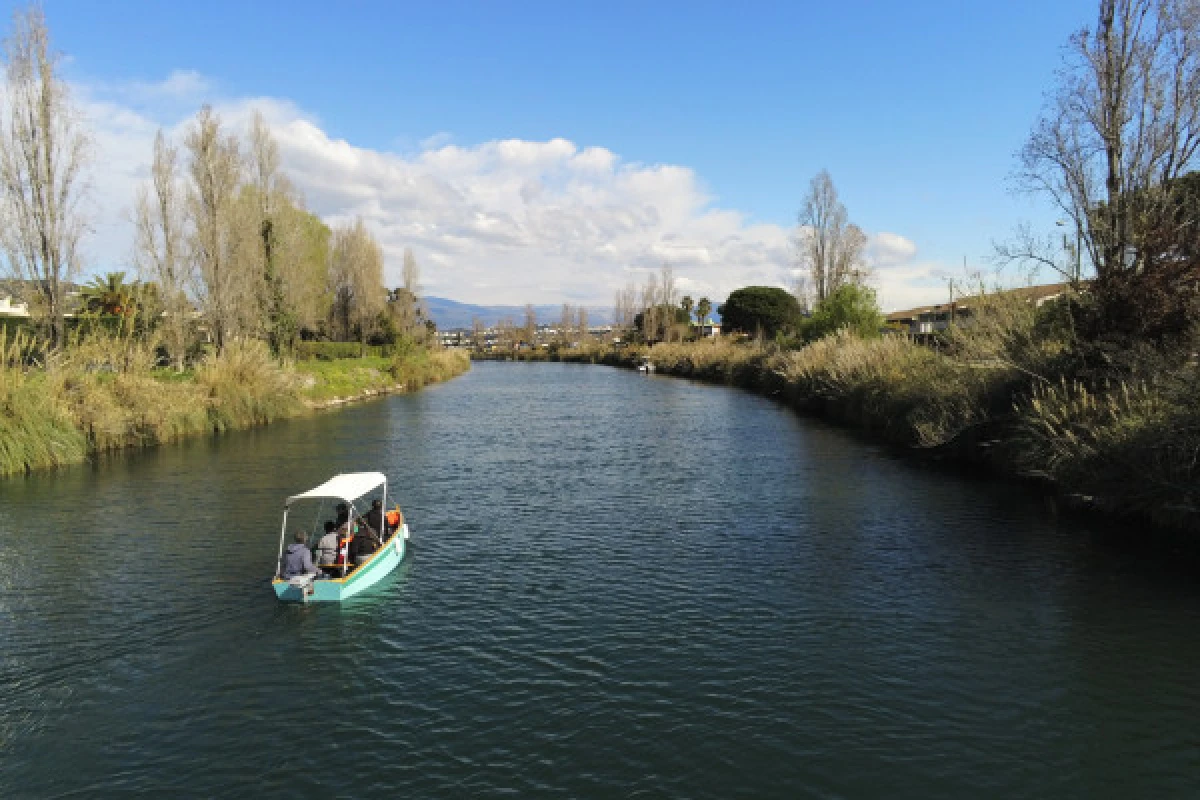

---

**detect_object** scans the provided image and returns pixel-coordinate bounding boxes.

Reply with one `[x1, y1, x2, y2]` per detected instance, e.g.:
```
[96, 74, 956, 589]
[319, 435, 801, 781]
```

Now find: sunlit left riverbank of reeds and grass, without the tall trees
[0, 338, 470, 476]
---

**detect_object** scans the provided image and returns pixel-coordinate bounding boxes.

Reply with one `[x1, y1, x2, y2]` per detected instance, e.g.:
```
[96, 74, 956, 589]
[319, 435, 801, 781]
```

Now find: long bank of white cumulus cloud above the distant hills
[72, 72, 955, 303]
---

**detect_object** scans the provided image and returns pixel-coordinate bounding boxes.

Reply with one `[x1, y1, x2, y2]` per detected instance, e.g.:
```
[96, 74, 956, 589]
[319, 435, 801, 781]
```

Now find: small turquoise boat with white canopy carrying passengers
[271, 473, 409, 603]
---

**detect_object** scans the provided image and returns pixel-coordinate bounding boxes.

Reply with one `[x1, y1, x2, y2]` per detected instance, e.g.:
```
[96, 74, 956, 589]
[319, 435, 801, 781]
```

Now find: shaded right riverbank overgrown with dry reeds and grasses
[501, 331, 1200, 535]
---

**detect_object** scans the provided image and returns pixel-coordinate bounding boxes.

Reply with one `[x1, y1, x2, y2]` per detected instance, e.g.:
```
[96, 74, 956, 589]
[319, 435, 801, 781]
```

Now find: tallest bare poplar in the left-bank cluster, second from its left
[184, 106, 244, 351]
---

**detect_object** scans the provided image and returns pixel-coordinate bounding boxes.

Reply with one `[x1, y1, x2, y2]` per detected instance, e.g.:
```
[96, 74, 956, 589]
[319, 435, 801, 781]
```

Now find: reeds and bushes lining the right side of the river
[566, 275, 1200, 530]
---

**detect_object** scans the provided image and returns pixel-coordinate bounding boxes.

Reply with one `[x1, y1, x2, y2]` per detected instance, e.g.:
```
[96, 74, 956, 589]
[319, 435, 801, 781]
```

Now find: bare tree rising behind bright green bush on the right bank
[796, 169, 866, 302]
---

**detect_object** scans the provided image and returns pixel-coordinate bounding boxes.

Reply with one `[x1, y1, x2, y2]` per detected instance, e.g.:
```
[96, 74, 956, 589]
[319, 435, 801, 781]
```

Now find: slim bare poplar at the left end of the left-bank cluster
[133, 130, 192, 371]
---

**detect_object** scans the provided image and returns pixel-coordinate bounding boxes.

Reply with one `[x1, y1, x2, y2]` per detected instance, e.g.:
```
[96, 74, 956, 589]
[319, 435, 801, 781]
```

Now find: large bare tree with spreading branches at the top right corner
[1017, 0, 1200, 279]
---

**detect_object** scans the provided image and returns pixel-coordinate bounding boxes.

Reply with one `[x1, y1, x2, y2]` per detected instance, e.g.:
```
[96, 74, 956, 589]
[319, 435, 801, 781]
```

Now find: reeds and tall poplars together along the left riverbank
[0, 6, 469, 475]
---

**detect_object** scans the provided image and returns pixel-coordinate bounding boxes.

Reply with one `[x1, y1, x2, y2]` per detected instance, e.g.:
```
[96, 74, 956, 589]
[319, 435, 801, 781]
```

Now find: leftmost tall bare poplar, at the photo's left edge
[0, 6, 90, 344]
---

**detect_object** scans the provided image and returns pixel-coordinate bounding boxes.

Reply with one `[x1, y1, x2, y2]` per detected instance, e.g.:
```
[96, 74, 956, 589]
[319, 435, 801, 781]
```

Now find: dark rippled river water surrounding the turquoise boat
[0, 363, 1200, 798]
